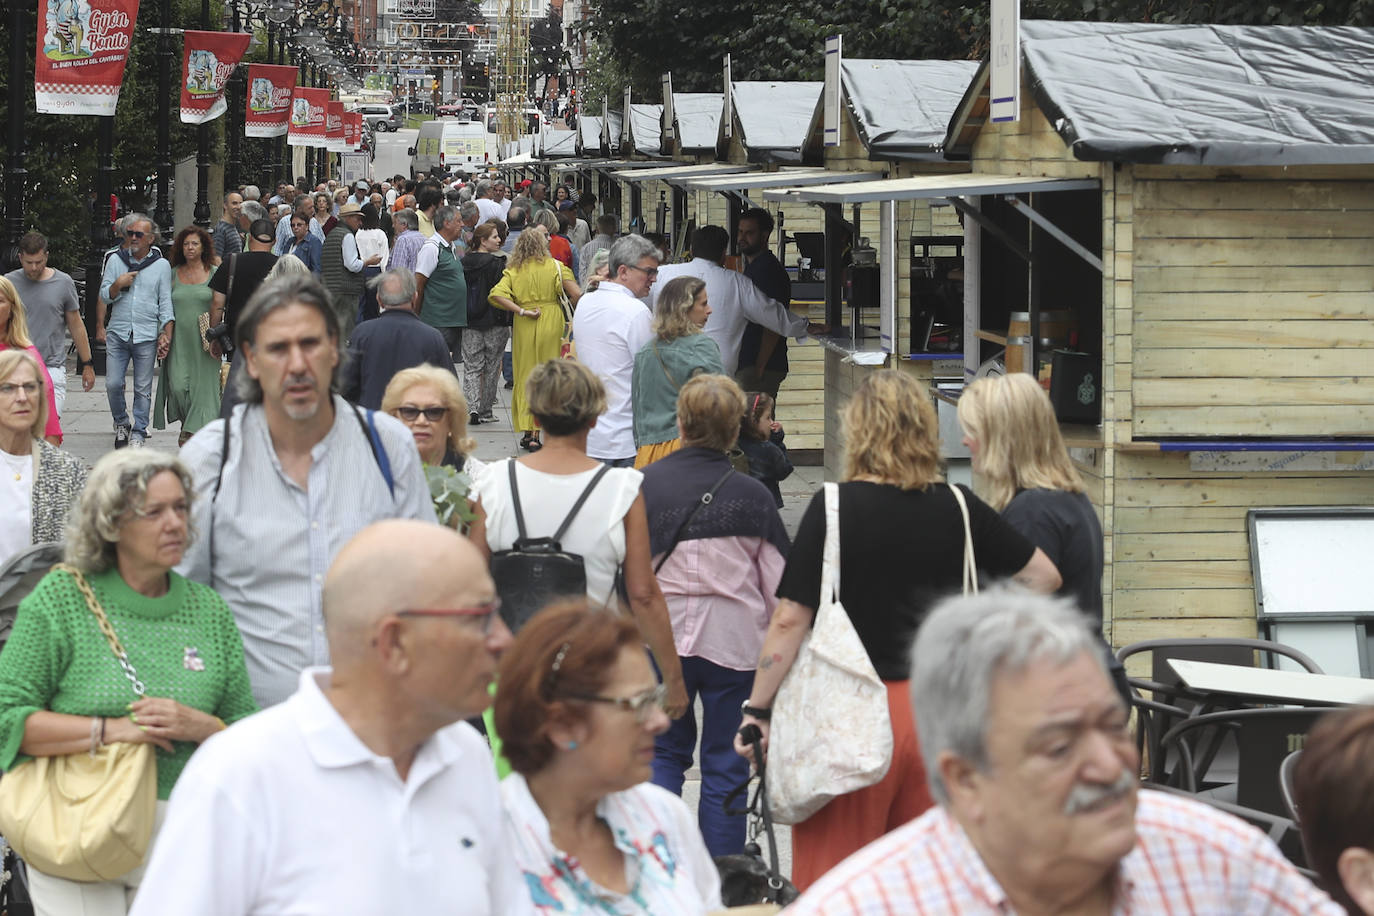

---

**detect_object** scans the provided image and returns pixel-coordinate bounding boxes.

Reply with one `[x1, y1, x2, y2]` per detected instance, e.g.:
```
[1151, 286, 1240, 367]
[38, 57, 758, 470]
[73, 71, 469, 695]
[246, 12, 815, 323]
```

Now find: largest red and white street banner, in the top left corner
[34, 0, 139, 117]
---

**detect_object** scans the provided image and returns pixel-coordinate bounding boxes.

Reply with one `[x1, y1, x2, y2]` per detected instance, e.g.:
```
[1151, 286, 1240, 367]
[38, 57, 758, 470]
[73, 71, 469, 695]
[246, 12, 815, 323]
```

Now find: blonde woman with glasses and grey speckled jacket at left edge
[0, 350, 87, 564]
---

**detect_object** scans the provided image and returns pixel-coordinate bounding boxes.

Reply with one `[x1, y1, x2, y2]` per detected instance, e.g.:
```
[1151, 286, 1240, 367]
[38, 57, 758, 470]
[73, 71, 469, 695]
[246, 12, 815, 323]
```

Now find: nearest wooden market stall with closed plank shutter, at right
[802, 22, 1374, 673]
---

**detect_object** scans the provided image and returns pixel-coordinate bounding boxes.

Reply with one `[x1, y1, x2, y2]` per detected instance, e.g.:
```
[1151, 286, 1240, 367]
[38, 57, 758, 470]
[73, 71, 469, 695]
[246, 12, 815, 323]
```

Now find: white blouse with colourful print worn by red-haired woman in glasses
[502, 773, 720, 916]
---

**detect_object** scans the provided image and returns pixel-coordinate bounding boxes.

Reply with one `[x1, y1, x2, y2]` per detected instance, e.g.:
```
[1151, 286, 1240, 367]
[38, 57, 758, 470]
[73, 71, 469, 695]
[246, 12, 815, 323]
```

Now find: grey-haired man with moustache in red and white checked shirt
[787, 591, 1342, 916]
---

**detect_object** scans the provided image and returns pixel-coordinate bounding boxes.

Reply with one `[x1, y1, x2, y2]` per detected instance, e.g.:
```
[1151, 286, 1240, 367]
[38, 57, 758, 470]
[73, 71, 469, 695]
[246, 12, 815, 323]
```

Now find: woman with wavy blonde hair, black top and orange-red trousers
[735, 369, 1059, 890]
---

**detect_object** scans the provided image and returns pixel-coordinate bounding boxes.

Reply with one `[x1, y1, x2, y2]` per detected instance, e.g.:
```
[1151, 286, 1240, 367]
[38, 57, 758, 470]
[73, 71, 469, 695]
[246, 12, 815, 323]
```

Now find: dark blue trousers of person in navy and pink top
[654, 655, 754, 856]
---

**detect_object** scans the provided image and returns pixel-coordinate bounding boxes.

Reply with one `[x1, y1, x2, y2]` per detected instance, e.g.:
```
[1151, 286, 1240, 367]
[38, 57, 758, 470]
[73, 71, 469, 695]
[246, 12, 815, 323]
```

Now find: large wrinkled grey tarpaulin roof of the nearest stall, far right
[1021, 21, 1374, 165]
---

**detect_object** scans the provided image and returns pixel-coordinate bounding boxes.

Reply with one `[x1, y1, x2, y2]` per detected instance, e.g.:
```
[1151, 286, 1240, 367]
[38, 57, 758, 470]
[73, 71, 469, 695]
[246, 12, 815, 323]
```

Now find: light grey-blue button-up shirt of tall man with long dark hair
[177, 396, 434, 709]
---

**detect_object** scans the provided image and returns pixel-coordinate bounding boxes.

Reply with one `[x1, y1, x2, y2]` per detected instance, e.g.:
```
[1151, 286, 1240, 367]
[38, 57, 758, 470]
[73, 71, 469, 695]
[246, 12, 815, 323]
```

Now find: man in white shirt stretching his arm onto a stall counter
[651, 225, 822, 376]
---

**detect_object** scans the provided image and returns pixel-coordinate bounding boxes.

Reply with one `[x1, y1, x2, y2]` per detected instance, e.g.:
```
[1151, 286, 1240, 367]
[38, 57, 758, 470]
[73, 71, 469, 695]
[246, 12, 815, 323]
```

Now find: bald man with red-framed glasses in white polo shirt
[132, 520, 532, 916]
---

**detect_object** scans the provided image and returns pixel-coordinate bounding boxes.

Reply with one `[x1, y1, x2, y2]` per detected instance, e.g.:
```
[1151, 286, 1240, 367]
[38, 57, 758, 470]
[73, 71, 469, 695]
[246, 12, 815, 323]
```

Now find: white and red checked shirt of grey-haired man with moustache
[787, 790, 1345, 916]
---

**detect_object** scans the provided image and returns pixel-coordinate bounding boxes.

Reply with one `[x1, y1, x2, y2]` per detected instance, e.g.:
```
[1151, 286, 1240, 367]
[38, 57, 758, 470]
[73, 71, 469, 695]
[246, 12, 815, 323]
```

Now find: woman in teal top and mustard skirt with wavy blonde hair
[629, 276, 738, 468]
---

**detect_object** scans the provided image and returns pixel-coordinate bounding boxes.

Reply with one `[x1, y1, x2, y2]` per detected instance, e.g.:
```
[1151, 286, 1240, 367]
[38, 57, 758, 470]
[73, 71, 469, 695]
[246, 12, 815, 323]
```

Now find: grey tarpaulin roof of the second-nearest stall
[841, 59, 978, 159]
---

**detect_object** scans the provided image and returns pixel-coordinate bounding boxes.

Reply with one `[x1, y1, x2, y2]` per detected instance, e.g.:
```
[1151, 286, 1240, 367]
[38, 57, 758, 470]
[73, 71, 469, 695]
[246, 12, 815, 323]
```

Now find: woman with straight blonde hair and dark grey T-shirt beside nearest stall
[959, 372, 1102, 633]
